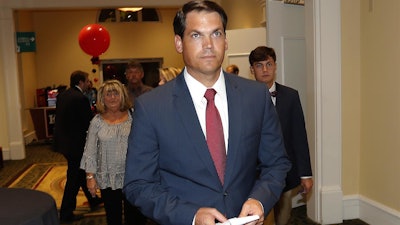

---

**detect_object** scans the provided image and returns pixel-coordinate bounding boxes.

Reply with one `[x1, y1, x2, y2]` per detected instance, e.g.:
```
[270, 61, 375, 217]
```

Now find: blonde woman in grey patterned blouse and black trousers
[81, 80, 146, 225]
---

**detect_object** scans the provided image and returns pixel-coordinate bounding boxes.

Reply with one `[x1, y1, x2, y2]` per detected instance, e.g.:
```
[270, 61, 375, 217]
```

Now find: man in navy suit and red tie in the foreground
[124, 1, 290, 225]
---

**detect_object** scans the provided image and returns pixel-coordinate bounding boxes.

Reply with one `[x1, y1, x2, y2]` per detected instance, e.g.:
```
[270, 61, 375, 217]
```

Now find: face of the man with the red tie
[175, 11, 228, 77]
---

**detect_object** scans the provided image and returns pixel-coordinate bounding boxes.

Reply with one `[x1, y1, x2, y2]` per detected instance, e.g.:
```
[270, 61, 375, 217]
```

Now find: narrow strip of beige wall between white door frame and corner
[341, 0, 361, 195]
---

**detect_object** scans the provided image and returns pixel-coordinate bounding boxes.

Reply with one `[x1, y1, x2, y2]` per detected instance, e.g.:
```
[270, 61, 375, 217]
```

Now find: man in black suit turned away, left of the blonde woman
[54, 71, 101, 222]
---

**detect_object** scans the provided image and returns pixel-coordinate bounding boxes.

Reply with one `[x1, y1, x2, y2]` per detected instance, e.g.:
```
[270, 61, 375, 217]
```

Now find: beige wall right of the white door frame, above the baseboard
[341, 0, 400, 211]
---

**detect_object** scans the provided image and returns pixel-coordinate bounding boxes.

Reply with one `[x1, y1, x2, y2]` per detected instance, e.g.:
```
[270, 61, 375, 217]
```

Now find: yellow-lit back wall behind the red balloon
[33, 9, 183, 87]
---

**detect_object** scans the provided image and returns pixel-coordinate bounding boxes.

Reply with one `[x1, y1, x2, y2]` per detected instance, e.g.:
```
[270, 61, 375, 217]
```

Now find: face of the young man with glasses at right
[250, 56, 276, 88]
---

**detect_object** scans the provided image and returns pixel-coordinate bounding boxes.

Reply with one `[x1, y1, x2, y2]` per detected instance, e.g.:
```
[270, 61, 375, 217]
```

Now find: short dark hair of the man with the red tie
[173, 0, 228, 38]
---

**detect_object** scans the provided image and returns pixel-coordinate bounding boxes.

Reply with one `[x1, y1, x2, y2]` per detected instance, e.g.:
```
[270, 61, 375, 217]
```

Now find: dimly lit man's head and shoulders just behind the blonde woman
[125, 60, 153, 104]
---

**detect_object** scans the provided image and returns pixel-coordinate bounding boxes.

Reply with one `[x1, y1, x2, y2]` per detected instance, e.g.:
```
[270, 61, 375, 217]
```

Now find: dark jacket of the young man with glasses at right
[275, 82, 312, 191]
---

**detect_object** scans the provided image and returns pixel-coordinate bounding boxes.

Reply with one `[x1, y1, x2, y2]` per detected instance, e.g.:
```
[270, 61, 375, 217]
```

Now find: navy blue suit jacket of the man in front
[124, 73, 290, 225]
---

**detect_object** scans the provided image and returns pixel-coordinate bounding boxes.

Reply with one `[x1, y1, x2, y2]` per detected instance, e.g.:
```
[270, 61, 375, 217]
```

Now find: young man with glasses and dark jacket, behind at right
[249, 46, 313, 225]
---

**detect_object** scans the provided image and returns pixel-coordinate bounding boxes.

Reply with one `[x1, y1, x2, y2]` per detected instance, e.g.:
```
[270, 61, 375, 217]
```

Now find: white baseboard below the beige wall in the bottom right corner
[343, 195, 400, 225]
